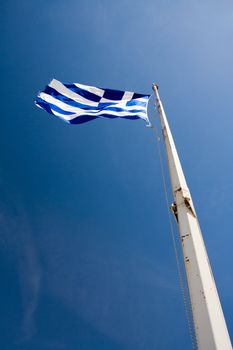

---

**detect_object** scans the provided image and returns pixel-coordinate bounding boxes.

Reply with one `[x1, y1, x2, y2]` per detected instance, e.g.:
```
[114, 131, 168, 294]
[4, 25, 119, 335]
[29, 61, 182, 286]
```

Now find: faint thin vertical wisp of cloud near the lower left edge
[0, 193, 42, 343]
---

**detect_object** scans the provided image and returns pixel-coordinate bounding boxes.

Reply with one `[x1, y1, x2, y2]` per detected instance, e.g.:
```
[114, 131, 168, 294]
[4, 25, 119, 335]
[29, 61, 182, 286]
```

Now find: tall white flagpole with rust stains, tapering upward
[152, 84, 232, 350]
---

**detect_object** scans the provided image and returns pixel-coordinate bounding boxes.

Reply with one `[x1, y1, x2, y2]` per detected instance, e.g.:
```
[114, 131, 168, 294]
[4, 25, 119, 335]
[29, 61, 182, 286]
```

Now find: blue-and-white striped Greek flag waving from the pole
[35, 79, 150, 124]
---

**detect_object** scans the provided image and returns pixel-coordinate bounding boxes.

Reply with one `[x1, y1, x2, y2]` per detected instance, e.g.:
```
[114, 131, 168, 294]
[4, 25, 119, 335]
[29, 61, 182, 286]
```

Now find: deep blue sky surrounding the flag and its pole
[0, 0, 233, 350]
